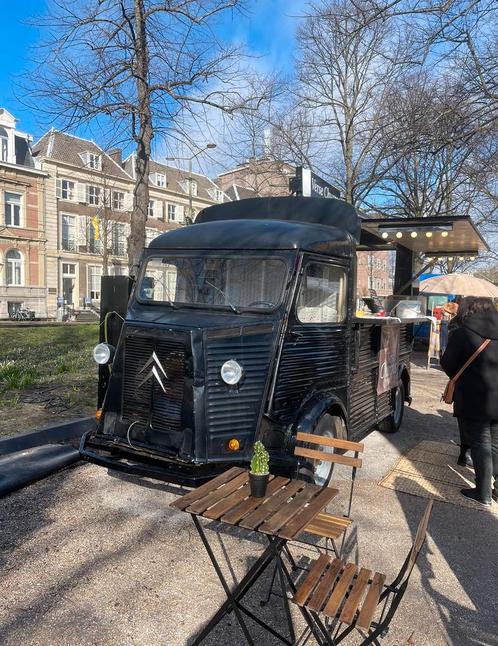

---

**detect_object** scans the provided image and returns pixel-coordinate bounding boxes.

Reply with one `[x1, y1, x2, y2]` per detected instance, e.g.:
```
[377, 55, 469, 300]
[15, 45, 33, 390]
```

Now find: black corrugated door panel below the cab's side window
[273, 327, 348, 420]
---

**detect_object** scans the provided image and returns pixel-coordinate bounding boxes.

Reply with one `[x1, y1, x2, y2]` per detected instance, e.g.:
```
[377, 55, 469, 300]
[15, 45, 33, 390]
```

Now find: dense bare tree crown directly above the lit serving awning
[376, 72, 475, 217]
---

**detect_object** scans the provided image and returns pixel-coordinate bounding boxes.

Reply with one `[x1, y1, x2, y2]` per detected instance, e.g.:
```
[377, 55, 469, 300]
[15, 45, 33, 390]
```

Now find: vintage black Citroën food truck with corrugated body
[80, 197, 484, 486]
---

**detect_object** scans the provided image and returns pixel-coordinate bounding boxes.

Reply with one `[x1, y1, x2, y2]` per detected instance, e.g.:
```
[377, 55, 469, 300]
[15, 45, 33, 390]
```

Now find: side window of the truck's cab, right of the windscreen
[297, 262, 346, 323]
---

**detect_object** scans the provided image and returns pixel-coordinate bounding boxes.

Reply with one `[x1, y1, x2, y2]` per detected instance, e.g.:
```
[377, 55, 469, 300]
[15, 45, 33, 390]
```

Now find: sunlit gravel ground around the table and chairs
[0, 367, 498, 646]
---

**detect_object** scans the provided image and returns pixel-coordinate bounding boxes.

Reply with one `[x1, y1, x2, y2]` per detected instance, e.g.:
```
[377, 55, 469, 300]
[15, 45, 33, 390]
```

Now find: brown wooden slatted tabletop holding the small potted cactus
[171, 467, 338, 540]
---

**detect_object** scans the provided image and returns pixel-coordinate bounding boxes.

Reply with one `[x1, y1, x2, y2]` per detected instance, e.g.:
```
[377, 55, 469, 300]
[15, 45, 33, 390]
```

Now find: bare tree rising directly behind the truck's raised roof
[296, 0, 407, 205]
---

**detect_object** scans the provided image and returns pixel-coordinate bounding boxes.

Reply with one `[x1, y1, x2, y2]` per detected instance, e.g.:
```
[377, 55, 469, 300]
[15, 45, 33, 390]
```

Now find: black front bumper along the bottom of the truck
[80, 431, 242, 487]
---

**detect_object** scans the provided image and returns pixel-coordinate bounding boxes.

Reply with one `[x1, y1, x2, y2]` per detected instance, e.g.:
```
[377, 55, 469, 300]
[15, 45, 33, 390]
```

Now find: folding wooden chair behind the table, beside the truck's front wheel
[294, 433, 364, 558]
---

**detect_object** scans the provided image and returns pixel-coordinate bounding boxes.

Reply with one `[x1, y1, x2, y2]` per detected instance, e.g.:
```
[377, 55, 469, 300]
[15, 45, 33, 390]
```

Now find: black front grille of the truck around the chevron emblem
[122, 336, 185, 432]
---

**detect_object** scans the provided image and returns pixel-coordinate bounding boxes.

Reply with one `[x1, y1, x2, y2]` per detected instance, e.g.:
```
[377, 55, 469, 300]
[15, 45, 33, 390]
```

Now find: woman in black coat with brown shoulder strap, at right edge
[441, 297, 498, 505]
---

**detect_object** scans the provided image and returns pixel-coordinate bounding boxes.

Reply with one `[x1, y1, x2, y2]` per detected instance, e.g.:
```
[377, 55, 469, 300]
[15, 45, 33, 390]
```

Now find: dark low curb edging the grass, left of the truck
[0, 417, 95, 455]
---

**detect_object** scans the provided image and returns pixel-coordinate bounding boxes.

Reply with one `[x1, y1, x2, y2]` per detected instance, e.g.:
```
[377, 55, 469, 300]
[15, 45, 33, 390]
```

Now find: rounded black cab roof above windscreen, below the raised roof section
[149, 219, 355, 257]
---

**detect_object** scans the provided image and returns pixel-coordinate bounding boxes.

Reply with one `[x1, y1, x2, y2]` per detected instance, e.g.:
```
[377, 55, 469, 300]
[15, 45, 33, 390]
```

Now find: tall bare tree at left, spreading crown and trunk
[26, 0, 264, 269]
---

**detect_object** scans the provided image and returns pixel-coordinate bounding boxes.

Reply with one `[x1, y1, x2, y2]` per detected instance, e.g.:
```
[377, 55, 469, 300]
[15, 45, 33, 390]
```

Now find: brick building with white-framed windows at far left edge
[0, 108, 46, 318]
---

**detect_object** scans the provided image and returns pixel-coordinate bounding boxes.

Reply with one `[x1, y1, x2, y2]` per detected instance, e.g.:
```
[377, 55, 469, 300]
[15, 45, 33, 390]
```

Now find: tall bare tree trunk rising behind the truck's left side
[128, 0, 153, 276]
